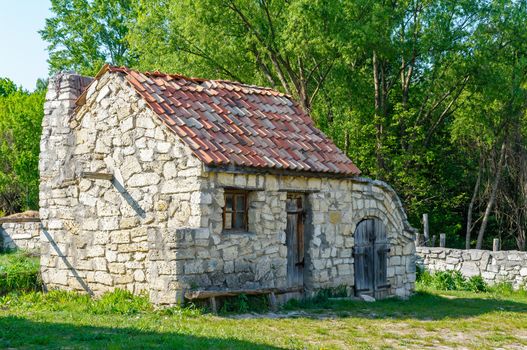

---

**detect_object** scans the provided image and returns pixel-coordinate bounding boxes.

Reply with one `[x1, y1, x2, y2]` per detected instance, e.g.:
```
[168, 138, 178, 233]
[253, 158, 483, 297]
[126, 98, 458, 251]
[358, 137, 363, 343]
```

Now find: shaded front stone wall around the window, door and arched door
[177, 172, 415, 297]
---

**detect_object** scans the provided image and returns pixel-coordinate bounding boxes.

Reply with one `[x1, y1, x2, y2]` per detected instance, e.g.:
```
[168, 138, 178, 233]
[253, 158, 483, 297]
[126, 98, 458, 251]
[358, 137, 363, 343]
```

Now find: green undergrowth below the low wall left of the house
[0, 250, 42, 295]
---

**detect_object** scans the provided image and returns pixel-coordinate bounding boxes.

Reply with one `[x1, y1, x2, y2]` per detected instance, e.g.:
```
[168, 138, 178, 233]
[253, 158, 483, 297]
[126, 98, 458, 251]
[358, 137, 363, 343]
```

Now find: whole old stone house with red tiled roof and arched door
[39, 66, 415, 304]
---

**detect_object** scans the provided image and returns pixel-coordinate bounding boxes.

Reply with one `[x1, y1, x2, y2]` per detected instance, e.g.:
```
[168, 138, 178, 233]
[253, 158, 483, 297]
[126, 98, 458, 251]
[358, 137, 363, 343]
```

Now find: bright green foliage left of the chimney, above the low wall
[0, 90, 45, 214]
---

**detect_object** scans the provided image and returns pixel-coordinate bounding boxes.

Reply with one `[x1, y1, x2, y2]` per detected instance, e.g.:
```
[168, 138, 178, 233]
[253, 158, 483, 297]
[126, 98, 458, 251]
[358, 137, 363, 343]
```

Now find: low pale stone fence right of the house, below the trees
[416, 247, 527, 288]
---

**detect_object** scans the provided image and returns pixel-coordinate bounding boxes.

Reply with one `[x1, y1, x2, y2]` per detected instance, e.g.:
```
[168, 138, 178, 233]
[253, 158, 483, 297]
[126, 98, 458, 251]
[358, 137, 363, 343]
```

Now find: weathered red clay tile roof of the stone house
[83, 66, 360, 175]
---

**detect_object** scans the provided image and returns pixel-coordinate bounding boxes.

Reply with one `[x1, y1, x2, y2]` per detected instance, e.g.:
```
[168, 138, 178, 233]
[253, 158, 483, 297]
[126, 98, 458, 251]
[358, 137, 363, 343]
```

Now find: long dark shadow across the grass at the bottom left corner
[0, 316, 279, 350]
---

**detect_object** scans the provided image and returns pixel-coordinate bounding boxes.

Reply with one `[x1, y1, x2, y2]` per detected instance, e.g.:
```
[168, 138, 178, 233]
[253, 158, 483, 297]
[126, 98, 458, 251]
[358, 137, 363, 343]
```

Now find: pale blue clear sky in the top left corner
[0, 0, 51, 91]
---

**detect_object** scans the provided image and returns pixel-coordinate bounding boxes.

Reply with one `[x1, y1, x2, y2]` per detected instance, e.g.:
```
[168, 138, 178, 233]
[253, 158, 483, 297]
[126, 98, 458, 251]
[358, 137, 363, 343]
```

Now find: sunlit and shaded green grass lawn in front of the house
[0, 291, 527, 350]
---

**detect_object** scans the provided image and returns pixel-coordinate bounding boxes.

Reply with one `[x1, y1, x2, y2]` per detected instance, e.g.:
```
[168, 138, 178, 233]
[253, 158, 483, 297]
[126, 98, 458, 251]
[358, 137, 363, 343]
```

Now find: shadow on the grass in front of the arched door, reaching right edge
[280, 292, 527, 320]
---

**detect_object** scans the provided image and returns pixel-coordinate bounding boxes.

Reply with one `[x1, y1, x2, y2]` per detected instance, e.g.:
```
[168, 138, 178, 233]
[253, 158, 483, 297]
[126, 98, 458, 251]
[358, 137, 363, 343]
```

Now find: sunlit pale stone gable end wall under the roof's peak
[41, 74, 206, 302]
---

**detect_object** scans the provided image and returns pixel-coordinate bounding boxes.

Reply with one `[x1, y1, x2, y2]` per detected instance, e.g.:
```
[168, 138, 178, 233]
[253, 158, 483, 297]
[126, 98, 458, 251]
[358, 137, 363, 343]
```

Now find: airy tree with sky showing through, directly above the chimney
[39, 0, 136, 75]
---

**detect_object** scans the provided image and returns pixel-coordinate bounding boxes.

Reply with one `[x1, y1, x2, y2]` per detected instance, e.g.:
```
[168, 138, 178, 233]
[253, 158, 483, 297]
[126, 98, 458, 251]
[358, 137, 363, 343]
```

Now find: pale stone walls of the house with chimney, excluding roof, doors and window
[40, 73, 415, 304]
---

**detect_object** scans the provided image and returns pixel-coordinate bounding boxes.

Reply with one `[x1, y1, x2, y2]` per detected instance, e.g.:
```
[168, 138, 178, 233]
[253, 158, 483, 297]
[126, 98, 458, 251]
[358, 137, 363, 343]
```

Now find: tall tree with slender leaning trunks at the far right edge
[453, 2, 527, 249]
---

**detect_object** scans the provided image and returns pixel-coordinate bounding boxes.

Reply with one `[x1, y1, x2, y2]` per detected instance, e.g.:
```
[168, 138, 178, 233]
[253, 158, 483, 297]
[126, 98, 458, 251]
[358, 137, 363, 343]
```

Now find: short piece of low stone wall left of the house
[0, 213, 41, 252]
